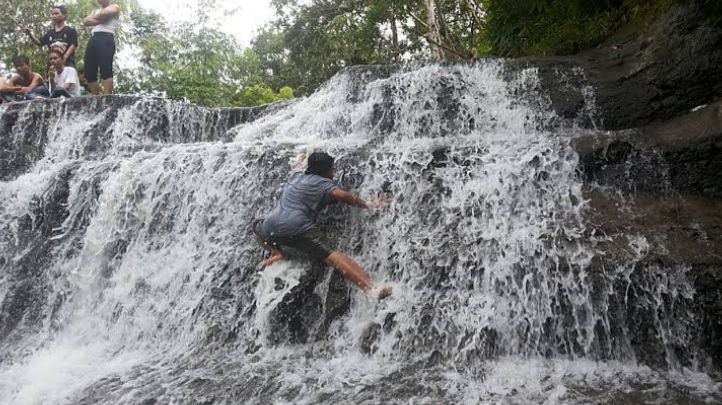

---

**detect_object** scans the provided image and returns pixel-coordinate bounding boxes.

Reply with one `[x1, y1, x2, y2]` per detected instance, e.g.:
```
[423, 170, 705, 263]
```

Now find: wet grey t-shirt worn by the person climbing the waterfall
[261, 172, 338, 238]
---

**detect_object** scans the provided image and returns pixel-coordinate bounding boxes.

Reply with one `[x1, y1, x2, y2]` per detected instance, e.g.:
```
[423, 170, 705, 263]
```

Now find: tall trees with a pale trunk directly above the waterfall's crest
[253, 0, 489, 94]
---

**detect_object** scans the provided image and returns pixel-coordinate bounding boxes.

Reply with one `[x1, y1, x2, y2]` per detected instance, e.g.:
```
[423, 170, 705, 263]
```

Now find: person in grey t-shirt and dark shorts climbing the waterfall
[253, 152, 391, 299]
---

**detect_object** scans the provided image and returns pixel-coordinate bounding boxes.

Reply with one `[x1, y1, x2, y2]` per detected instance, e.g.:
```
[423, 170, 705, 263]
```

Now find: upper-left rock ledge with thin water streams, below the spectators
[0, 96, 273, 181]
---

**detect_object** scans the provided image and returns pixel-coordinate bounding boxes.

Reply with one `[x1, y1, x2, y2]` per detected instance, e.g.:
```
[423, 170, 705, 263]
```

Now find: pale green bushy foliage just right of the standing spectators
[118, 10, 293, 107]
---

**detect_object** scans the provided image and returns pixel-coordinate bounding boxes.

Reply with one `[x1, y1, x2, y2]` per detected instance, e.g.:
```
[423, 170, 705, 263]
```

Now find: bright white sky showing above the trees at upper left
[140, 0, 273, 47]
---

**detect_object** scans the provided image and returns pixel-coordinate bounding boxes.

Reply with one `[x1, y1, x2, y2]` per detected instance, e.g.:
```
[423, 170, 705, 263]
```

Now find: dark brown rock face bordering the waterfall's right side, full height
[556, 5, 722, 370]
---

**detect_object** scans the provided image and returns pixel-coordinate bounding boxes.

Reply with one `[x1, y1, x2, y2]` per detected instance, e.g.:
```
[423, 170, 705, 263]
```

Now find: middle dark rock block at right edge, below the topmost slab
[576, 103, 722, 198]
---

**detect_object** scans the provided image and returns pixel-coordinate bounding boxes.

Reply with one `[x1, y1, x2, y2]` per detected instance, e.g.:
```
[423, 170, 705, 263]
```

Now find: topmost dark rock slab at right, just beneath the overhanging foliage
[528, 5, 722, 130]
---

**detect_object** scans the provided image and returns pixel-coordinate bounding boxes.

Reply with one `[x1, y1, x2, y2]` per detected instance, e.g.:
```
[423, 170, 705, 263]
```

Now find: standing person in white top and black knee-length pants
[83, 0, 120, 95]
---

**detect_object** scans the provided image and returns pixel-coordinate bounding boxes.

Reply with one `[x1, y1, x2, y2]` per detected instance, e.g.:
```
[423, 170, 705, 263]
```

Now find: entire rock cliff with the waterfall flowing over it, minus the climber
[0, 3, 722, 404]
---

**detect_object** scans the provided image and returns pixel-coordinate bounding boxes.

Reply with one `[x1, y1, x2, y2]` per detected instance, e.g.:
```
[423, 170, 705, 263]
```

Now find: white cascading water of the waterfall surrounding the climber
[0, 61, 720, 404]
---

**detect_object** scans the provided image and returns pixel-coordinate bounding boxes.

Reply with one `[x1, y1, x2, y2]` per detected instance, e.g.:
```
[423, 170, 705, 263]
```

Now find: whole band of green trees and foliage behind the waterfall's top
[5, 0, 722, 107]
